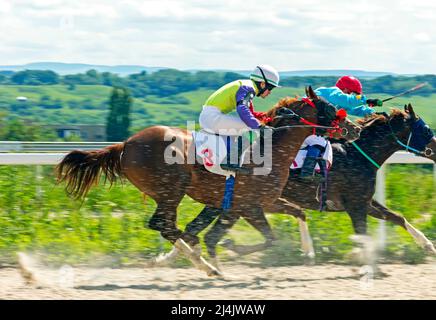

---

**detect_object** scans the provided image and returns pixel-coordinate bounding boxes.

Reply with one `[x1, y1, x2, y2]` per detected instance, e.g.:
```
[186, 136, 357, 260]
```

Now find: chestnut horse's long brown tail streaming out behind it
[56, 143, 124, 199]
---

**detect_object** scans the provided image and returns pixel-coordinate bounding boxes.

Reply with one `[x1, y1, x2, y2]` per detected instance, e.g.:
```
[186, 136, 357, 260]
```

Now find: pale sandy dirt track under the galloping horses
[0, 264, 436, 300]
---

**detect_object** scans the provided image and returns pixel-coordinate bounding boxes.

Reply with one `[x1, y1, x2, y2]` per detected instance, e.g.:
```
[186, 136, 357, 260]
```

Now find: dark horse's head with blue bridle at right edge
[389, 103, 436, 162]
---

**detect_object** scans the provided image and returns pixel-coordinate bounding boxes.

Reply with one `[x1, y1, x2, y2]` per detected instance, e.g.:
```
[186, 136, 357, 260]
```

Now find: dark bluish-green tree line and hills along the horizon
[0, 69, 436, 95]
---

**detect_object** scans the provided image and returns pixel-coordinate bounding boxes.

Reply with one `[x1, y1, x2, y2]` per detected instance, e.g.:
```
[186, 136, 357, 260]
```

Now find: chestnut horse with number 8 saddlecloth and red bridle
[56, 87, 360, 275]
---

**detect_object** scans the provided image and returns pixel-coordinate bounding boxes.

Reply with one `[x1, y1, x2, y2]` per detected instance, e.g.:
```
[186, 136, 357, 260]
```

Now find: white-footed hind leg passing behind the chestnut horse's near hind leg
[153, 206, 222, 266]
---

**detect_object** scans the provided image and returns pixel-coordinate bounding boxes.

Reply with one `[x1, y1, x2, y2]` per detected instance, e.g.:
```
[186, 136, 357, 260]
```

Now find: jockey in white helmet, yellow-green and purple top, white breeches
[199, 65, 280, 171]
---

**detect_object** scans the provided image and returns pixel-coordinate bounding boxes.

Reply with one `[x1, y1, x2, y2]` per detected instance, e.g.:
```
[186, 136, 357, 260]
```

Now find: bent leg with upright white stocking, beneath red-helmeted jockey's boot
[265, 198, 315, 264]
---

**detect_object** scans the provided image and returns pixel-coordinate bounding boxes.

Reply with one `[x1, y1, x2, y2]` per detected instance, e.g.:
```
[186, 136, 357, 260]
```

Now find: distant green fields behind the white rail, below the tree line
[0, 85, 436, 133]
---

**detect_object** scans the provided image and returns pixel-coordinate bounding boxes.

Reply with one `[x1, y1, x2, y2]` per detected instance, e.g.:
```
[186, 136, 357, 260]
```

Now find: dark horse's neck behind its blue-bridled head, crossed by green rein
[350, 124, 401, 165]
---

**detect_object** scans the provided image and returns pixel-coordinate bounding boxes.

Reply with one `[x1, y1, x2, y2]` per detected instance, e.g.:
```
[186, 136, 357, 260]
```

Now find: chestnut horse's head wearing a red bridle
[268, 86, 361, 141]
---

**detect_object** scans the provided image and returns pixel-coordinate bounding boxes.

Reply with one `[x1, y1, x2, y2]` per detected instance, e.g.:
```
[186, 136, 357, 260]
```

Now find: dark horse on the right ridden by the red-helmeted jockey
[265, 104, 436, 259]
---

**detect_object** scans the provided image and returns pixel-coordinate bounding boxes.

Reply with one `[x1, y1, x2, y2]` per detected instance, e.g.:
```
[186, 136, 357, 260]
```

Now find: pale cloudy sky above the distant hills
[0, 0, 436, 74]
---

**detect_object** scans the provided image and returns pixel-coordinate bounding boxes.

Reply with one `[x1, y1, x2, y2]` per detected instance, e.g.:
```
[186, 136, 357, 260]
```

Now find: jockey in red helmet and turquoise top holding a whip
[298, 76, 383, 179]
